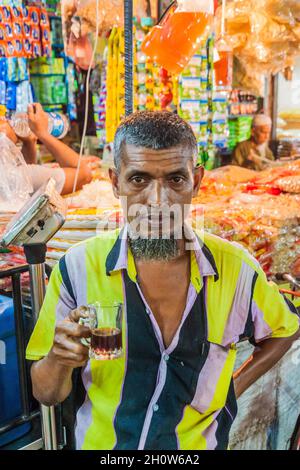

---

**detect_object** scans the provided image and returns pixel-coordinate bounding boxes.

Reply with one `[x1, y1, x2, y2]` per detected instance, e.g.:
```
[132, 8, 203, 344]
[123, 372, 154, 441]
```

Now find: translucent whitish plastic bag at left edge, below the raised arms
[0, 133, 33, 212]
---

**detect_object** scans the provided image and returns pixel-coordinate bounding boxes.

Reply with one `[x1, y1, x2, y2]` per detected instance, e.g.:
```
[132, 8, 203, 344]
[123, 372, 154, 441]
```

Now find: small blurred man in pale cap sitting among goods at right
[232, 114, 274, 171]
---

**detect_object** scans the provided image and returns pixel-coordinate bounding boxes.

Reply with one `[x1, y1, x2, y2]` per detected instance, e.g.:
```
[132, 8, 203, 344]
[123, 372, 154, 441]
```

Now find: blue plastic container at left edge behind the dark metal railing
[0, 295, 31, 446]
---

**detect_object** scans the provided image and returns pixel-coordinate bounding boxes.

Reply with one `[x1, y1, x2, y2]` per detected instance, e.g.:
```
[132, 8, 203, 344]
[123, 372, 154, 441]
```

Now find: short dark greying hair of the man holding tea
[114, 111, 198, 170]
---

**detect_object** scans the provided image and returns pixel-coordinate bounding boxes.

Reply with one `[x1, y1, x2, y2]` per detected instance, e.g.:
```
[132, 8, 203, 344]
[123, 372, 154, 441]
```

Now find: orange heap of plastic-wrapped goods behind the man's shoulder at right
[193, 163, 300, 276]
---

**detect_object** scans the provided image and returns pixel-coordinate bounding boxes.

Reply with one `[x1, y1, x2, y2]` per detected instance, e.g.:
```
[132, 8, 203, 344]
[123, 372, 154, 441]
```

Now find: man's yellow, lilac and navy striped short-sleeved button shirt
[27, 229, 299, 450]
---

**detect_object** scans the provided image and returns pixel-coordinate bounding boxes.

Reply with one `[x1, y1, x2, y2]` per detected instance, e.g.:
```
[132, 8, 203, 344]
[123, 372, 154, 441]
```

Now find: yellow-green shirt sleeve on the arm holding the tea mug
[26, 263, 76, 361]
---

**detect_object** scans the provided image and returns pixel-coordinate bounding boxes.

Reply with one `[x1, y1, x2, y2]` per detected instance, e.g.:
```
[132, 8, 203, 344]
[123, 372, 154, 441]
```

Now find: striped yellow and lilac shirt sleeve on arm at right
[251, 268, 300, 342]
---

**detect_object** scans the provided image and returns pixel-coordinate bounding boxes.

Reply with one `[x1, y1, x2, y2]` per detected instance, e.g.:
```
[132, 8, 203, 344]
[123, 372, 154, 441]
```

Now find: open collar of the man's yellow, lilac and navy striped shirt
[106, 225, 219, 292]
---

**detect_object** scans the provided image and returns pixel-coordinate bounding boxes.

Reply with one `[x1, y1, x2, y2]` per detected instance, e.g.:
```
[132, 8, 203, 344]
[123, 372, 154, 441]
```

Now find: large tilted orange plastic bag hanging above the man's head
[142, 0, 214, 74]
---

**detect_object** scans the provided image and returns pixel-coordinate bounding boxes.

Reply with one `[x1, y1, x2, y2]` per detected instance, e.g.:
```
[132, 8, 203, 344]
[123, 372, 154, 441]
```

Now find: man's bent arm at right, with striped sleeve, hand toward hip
[234, 269, 300, 398]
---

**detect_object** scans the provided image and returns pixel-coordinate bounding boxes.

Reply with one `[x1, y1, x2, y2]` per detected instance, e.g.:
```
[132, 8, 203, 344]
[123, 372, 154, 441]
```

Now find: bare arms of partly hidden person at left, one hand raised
[0, 103, 92, 195]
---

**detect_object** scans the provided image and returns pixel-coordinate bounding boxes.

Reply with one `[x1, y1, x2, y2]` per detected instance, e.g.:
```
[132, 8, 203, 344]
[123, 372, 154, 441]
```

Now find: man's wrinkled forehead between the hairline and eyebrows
[123, 144, 193, 165]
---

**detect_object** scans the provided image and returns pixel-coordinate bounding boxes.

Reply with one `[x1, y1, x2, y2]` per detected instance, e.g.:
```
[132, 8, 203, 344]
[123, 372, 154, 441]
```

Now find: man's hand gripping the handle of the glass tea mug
[48, 307, 91, 368]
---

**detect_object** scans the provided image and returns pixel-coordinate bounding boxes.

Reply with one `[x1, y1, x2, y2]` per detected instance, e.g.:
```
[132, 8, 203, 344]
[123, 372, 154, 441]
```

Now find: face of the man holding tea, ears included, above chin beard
[110, 145, 203, 238]
